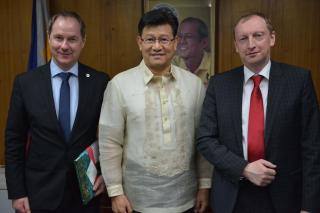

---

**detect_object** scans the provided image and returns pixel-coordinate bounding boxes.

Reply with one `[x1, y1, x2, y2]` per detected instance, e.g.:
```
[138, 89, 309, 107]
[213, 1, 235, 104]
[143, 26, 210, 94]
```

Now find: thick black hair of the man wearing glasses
[138, 7, 179, 37]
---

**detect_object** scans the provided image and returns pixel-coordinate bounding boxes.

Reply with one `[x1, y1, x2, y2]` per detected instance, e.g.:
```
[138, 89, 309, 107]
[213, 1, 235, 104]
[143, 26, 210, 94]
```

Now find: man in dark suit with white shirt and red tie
[197, 13, 320, 213]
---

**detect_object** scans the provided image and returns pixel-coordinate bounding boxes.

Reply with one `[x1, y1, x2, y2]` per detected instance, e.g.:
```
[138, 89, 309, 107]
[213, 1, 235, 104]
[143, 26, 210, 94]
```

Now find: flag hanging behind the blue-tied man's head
[28, 0, 51, 70]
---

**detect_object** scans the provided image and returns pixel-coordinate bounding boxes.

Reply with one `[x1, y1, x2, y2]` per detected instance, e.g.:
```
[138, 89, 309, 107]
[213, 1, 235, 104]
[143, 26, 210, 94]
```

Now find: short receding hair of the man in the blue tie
[48, 11, 86, 39]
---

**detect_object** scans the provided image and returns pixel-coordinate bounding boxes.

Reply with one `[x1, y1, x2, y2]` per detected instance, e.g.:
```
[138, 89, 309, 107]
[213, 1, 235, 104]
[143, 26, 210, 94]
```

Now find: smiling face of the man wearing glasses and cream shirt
[137, 24, 177, 74]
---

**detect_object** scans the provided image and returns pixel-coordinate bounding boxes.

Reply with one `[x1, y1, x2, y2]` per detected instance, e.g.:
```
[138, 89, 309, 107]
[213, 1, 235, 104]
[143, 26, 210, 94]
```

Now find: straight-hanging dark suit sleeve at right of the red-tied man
[301, 72, 320, 212]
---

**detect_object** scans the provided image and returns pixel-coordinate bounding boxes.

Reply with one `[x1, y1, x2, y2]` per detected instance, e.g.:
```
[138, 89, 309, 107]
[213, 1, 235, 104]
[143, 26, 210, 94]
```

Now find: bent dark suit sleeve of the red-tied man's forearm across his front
[197, 76, 247, 183]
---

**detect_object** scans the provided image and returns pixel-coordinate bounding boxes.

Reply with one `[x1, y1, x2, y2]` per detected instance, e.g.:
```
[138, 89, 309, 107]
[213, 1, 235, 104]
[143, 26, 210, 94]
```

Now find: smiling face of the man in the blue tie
[49, 16, 85, 70]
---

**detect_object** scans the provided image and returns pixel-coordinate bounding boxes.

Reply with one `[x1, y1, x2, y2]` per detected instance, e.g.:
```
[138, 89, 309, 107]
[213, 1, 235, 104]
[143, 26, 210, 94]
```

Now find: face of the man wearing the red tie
[234, 15, 275, 72]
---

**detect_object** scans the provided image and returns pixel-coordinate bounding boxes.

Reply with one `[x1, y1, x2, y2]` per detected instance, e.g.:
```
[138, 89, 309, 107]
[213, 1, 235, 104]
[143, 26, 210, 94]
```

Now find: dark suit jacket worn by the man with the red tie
[197, 62, 320, 213]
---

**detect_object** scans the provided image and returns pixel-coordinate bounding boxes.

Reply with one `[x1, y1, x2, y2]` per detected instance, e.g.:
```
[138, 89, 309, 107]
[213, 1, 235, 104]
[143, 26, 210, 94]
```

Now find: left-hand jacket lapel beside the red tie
[231, 66, 244, 155]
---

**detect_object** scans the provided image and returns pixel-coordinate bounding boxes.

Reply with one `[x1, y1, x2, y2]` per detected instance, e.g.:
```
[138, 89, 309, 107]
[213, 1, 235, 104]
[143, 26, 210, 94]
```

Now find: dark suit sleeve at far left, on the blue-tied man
[5, 77, 29, 199]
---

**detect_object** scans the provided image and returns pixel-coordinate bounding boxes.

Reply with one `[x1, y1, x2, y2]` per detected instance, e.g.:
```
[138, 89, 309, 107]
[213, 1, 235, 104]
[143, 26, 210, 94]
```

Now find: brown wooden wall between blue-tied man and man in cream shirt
[50, 0, 142, 76]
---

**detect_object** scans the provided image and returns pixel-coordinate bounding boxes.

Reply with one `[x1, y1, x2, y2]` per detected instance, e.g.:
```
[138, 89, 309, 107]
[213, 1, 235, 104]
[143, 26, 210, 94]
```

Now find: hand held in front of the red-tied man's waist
[243, 159, 277, 186]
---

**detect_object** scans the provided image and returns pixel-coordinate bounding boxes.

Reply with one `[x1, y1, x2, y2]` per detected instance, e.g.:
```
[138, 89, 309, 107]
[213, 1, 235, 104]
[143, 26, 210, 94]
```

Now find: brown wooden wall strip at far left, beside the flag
[0, 0, 32, 165]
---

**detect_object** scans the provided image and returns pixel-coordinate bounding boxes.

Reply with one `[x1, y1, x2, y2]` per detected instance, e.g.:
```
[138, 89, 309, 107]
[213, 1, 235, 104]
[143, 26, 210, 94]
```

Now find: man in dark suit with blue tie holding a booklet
[5, 12, 109, 213]
